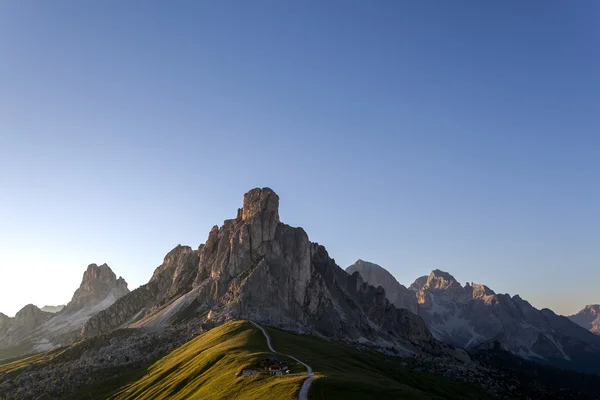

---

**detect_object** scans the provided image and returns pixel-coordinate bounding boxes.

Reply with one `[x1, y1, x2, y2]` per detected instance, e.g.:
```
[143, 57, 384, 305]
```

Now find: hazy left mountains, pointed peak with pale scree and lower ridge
[0, 264, 129, 359]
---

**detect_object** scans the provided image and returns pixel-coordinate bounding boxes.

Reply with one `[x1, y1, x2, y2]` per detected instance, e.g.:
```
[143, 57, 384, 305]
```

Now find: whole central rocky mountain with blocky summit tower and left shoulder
[83, 188, 439, 351]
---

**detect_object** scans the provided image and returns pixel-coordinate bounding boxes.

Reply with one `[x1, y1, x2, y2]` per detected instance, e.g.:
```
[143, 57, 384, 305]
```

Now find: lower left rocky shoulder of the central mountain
[82, 245, 198, 337]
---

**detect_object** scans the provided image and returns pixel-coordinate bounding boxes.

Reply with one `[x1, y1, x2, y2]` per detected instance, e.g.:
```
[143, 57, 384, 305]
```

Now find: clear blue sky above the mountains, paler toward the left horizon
[0, 0, 600, 315]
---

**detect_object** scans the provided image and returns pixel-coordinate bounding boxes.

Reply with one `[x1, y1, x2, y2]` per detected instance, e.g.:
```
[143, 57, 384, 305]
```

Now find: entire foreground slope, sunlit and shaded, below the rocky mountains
[0, 321, 600, 400]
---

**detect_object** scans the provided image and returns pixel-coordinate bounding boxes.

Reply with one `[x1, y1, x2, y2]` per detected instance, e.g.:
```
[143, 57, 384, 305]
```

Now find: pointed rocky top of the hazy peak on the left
[64, 264, 129, 312]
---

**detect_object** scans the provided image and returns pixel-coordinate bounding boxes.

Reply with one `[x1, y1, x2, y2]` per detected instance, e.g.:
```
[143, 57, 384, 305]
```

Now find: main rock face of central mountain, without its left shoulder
[194, 188, 435, 347]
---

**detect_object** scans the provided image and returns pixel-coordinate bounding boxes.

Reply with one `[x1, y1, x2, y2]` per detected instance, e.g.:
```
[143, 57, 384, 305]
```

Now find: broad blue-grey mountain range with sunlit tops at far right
[411, 270, 600, 371]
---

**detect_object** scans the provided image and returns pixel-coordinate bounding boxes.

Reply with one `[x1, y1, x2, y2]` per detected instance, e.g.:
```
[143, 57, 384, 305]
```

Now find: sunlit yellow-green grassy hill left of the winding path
[111, 321, 305, 400]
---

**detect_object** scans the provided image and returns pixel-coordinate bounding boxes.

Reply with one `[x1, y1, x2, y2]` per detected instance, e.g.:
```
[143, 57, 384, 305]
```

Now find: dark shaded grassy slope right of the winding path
[266, 328, 493, 400]
